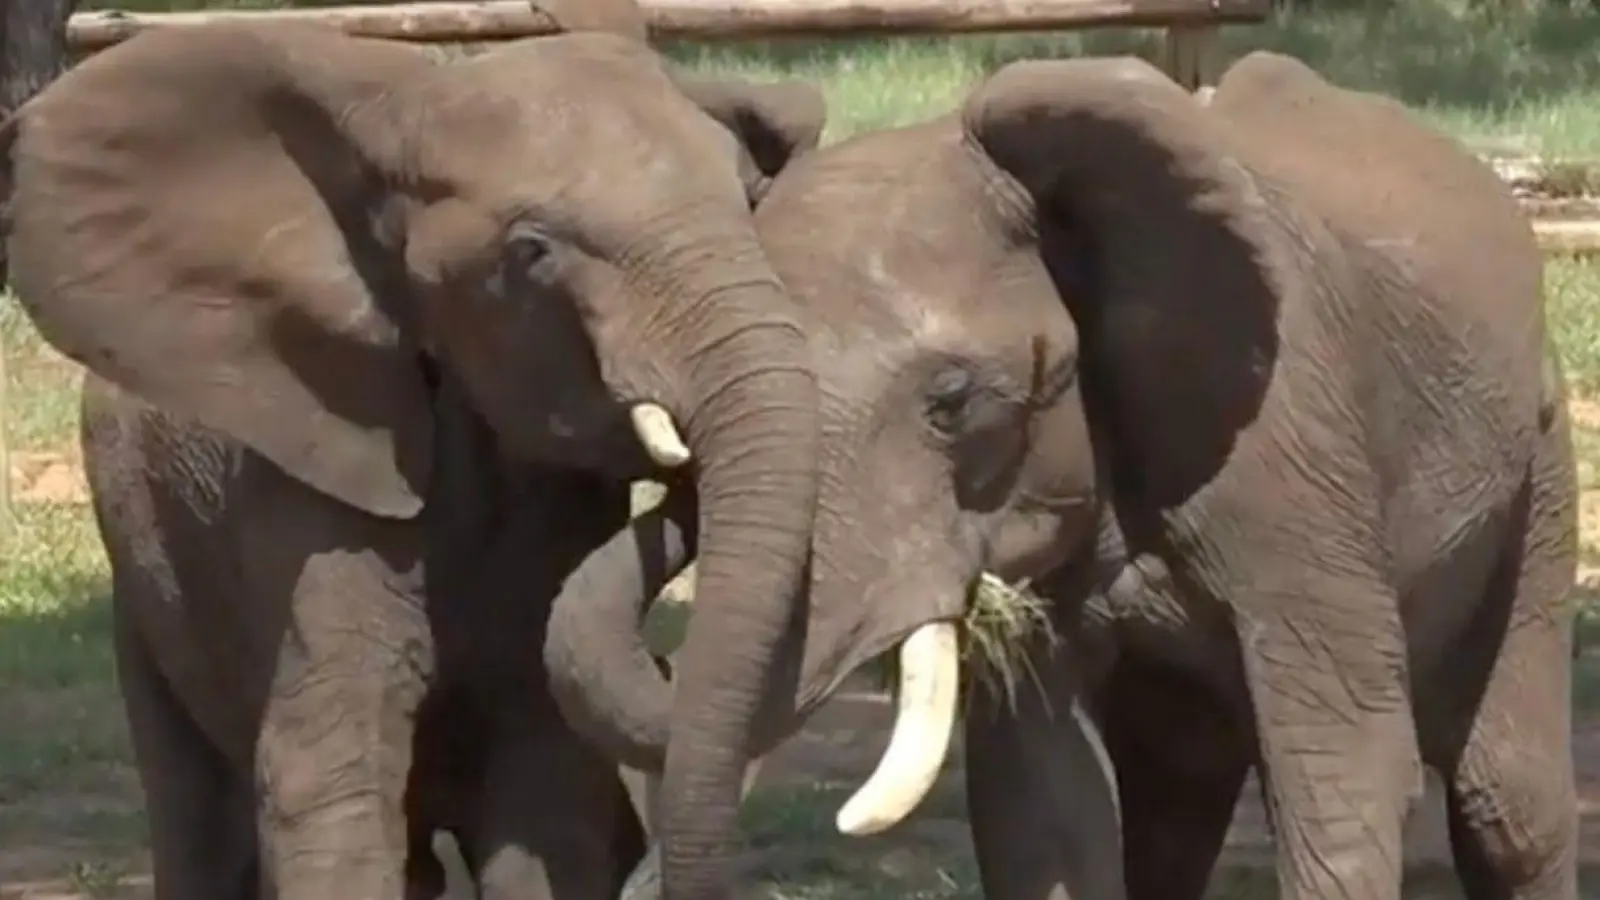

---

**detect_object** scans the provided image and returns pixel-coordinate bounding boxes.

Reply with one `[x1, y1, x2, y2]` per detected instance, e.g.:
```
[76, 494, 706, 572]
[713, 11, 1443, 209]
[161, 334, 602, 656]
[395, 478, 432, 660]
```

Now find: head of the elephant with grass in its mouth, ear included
[547, 59, 1299, 890]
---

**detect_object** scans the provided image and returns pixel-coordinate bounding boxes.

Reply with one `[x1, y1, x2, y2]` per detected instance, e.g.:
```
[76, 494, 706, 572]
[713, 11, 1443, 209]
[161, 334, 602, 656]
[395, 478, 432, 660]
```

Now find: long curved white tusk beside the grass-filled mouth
[834, 621, 962, 836]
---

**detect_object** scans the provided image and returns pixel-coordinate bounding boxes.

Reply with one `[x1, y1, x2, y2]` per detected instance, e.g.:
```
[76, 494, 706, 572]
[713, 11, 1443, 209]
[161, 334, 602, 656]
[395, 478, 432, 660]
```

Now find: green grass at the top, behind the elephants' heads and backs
[652, 0, 1600, 155]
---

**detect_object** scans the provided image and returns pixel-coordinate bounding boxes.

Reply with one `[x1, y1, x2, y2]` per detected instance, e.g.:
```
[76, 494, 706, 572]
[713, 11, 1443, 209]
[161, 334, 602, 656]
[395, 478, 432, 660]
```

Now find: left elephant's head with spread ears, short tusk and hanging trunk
[0, 15, 822, 890]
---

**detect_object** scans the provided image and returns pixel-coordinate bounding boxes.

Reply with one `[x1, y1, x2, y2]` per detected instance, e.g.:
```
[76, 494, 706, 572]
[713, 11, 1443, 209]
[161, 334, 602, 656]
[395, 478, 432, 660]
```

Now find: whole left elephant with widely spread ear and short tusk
[0, 14, 821, 900]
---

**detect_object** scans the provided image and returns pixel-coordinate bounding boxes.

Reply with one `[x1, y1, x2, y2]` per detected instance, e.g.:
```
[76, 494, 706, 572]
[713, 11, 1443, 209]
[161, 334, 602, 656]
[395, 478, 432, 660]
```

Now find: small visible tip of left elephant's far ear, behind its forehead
[675, 77, 827, 202]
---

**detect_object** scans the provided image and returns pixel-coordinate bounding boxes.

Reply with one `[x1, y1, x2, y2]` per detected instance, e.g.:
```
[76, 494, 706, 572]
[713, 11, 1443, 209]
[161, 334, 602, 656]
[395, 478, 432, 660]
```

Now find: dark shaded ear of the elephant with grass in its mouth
[962, 59, 1286, 508]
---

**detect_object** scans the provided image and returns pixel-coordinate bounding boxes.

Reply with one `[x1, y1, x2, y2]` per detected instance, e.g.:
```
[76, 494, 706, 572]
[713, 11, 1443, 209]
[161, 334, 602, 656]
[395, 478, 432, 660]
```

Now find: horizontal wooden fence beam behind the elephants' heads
[67, 0, 1270, 53]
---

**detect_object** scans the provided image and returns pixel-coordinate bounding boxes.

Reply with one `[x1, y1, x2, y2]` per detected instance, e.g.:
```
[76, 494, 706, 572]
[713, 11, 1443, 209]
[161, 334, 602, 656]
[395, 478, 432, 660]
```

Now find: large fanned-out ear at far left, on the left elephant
[3, 26, 432, 517]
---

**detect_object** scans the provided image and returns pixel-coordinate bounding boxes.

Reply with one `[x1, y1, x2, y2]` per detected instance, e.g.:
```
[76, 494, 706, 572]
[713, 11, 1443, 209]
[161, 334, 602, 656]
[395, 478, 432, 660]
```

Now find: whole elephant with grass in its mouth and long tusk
[547, 53, 1576, 900]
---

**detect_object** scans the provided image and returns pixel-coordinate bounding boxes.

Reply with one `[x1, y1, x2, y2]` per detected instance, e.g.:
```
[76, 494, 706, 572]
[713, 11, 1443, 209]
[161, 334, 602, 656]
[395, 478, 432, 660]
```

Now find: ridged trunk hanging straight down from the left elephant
[656, 265, 818, 900]
